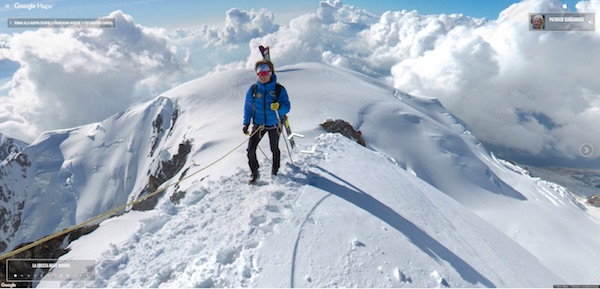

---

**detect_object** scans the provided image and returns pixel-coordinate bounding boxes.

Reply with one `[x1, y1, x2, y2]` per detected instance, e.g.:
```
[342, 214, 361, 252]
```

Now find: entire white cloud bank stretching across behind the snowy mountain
[0, 0, 600, 166]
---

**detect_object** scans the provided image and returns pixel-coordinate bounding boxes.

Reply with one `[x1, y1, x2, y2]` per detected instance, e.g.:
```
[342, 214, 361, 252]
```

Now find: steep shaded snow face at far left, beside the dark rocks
[0, 94, 183, 249]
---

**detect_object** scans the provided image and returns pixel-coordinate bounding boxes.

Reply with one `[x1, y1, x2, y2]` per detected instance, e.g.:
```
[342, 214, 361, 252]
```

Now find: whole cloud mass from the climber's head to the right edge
[246, 0, 600, 164]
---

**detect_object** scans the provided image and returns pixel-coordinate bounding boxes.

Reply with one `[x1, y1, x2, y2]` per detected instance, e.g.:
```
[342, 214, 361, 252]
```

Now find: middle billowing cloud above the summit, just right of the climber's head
[247, 0, 484, 77]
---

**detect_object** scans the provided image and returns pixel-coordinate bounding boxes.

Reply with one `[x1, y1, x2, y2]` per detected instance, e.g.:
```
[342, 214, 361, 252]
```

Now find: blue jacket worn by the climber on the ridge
[244, 74, 290, 126]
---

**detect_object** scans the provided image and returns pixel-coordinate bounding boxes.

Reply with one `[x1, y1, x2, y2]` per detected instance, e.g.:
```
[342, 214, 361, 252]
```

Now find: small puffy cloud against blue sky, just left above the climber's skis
[200, 8, 279, 45]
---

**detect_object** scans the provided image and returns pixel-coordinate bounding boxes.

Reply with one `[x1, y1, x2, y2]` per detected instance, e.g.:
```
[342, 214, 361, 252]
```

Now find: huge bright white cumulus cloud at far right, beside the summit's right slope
[391, 1, 600, 159]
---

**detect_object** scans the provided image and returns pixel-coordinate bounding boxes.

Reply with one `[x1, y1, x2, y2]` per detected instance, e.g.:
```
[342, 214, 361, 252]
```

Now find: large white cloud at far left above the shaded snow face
[0, 11, 183, 141]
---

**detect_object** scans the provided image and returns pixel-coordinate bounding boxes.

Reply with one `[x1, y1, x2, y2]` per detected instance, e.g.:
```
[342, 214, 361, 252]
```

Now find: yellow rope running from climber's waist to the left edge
[0, 125, 263, 260]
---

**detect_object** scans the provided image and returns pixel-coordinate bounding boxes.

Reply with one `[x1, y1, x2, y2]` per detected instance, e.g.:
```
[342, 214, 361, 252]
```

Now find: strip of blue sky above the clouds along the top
[0, 0, 577, 29]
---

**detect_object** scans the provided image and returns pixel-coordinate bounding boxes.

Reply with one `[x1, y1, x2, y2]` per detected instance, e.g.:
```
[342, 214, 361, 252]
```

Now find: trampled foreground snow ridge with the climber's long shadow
[41, 134, 563, 288]
